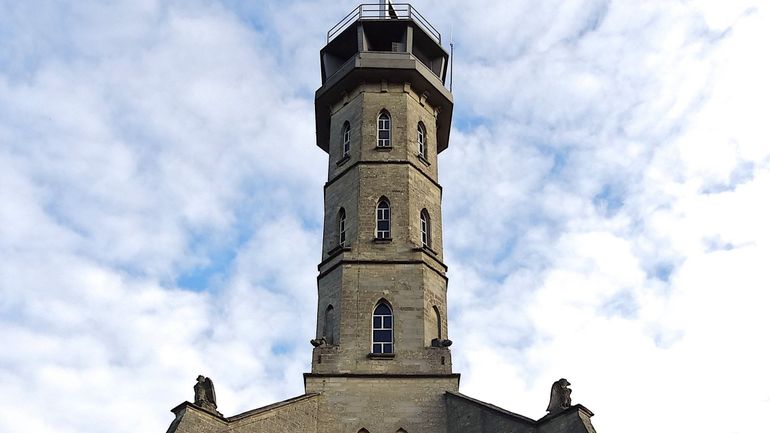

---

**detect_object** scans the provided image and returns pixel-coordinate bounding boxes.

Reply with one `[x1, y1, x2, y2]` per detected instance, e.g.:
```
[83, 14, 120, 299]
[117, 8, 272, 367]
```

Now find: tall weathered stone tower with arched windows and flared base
[168, 8, 595, 433]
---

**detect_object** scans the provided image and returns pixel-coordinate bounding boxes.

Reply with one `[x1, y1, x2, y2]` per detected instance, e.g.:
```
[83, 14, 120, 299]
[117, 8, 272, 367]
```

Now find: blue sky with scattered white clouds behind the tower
[0, 0, 770, 433]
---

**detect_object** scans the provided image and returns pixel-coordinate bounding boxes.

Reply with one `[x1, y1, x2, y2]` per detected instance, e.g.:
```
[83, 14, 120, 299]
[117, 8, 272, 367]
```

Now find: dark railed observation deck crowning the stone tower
[315, 3, 454, 152]
